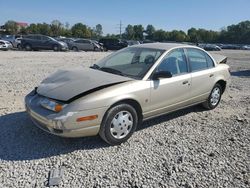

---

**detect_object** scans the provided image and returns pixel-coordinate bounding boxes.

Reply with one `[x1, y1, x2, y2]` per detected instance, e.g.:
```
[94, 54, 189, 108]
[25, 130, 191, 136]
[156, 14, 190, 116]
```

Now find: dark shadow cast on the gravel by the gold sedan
[0, 106, 204, 161]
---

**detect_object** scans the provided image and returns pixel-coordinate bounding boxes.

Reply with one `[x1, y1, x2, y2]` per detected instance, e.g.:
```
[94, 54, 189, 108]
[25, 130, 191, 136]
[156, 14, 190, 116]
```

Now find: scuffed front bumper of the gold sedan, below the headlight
[25, 91, 105, 137]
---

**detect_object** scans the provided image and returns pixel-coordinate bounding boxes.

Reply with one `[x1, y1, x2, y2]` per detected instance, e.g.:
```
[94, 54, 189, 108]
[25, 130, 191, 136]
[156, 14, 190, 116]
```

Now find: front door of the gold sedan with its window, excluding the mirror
[148, 48, 191, 116]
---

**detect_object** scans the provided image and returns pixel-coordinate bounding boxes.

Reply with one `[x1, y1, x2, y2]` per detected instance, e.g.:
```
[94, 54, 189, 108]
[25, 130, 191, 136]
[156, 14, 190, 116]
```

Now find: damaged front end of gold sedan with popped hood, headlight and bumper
[25, 68, 135, 137]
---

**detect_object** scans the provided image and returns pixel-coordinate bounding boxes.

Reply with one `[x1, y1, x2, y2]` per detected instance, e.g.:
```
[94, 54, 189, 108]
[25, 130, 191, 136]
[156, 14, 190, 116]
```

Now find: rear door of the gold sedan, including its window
[186, 48, 215, 102]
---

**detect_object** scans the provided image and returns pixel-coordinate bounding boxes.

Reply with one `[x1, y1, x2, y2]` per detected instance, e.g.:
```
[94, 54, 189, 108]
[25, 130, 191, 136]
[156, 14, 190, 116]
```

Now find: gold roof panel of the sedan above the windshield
[133, 42, 191, 50]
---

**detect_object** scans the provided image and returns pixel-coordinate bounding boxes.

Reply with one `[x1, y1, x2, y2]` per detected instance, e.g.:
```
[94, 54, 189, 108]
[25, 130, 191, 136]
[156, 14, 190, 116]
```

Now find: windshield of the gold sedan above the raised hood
[91, 47, 164, 79]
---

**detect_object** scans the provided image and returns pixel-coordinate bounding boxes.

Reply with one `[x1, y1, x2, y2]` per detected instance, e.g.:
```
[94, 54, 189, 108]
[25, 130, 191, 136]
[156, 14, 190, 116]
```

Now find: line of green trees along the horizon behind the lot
[1, 20, 250, 44]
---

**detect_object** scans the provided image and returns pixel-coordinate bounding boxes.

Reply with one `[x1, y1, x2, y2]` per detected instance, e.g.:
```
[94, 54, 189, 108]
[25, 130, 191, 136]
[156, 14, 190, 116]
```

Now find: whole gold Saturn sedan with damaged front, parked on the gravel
[25, 43, 230, 145]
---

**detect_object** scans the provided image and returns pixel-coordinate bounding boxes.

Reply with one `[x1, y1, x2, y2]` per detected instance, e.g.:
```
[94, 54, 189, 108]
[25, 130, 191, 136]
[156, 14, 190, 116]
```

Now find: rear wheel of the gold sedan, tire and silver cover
[202, 83, 222, 110]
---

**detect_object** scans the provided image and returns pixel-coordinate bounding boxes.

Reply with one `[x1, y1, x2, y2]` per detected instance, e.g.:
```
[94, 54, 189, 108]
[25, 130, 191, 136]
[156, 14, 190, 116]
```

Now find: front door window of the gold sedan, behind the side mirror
[156, 49, 188, 76]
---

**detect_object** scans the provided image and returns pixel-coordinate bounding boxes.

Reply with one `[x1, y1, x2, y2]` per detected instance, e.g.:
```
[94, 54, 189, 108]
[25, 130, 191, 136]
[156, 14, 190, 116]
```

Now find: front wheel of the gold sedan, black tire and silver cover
[99, 104, 138, 145]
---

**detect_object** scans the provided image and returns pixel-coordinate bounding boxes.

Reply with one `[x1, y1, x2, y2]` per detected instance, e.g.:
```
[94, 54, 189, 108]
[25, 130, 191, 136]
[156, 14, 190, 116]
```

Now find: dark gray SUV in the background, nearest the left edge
[21, 35, 68, 51]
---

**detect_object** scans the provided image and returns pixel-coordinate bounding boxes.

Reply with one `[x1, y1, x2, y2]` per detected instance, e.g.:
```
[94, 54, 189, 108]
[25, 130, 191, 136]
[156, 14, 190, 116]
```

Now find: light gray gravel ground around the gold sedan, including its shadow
[0, 50, 250, 188]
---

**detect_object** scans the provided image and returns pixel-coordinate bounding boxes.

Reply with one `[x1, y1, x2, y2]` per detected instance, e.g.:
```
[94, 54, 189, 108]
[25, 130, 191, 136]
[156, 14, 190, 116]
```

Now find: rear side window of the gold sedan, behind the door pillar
[187, 48, 214, 72]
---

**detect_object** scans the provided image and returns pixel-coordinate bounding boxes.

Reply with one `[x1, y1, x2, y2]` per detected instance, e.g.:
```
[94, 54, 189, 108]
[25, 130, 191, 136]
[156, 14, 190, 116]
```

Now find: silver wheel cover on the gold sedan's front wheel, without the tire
[110, 111, 134, 139]
